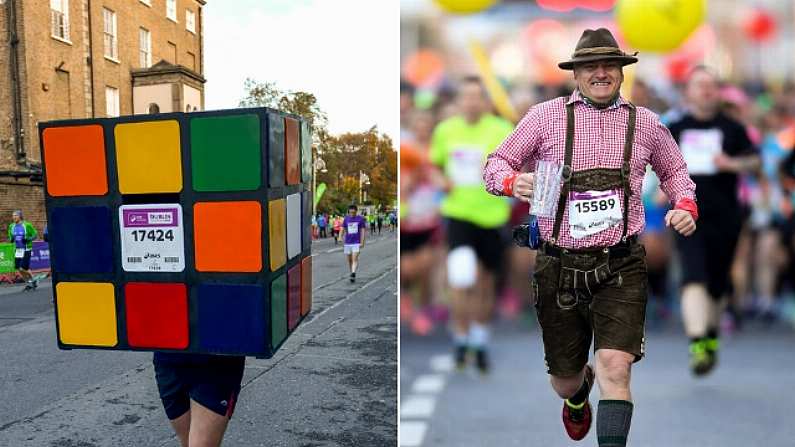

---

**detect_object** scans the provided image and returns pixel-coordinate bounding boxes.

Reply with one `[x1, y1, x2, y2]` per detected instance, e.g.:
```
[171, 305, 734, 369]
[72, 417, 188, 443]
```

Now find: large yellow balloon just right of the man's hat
[616, 0, 706, 53]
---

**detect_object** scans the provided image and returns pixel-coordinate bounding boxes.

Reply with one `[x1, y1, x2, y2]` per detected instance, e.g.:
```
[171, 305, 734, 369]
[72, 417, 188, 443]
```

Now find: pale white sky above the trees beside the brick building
[203, 0, 400, 145]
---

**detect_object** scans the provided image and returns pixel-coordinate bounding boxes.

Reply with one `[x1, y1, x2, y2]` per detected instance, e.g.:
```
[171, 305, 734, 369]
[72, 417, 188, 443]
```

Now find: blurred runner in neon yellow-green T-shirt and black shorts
[430, 77, 513, 373]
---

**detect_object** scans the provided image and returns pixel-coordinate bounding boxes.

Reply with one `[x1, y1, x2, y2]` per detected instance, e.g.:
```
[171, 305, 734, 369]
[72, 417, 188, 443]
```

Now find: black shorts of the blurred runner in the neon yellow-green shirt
[447, 219, 505, 272]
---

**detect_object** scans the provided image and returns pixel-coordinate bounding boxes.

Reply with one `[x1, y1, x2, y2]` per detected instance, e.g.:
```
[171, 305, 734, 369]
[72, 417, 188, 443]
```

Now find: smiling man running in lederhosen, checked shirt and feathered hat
[484, 28, 698, 447]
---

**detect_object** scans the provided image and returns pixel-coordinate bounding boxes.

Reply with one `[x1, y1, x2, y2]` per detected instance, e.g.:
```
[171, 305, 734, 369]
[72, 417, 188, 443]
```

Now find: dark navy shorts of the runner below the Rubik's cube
[153, 353, 246, 420]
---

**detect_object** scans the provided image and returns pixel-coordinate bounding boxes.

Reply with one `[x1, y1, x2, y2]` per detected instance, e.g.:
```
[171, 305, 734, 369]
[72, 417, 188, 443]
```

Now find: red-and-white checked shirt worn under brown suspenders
[483, 90, 696, 249]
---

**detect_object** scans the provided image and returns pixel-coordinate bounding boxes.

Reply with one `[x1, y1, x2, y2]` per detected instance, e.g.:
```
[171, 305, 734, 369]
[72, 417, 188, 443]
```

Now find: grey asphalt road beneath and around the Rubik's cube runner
[0, 232, 397, 447]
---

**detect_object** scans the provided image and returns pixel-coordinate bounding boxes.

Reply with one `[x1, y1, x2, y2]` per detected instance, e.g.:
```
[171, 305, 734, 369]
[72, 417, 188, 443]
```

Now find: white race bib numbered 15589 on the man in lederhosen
[569, 190, 624, 239]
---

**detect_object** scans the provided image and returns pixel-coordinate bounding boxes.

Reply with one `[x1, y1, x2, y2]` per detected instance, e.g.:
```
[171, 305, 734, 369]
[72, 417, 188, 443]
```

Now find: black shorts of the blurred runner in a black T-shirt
[676, 216, 742, 300]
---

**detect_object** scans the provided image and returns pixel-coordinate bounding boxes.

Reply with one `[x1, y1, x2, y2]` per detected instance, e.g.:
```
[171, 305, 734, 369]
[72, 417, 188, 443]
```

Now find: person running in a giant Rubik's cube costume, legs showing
[39, 108, 312, 445]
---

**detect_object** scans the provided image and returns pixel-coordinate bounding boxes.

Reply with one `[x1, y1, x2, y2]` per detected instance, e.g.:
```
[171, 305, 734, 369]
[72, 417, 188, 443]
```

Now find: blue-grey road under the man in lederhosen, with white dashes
[400, 316, 795, 447]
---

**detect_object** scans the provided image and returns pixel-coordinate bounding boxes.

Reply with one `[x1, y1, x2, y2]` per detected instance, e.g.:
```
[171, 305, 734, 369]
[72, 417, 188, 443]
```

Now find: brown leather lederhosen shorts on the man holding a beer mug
[533, 244, 648, 377]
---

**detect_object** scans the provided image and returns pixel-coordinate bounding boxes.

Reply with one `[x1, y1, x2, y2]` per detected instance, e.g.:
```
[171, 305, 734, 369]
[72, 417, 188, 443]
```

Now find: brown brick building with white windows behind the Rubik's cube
[0, 0, 205, 234]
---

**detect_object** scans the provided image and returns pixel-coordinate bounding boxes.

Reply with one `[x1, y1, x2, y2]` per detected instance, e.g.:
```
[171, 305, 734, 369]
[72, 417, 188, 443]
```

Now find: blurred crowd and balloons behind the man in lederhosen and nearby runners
[400, 0, 795, 335]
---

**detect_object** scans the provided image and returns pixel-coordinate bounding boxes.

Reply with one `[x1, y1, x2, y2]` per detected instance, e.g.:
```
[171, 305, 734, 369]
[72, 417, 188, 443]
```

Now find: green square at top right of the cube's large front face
[190, 115, 262, 192]
